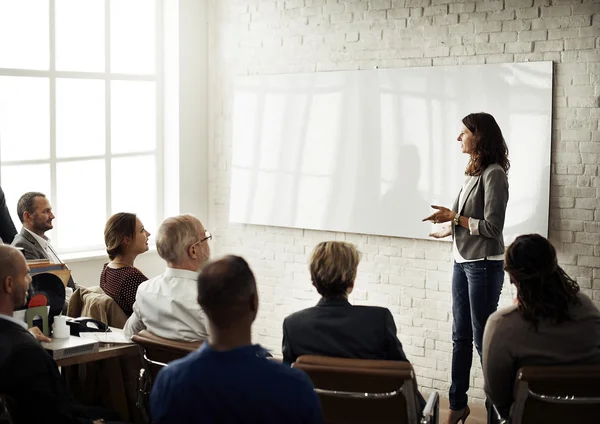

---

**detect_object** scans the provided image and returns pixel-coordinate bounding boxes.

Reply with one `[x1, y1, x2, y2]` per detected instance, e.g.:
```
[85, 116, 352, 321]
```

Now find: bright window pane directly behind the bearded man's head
[0, 164, 52, 238]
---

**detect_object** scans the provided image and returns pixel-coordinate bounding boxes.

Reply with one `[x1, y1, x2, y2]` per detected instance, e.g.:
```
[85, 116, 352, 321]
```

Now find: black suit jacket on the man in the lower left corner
[0, 318, 78, 424]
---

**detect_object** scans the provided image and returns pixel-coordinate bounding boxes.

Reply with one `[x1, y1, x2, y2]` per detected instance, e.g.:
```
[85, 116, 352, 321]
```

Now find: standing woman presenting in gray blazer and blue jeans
[423, 113, 510, 424]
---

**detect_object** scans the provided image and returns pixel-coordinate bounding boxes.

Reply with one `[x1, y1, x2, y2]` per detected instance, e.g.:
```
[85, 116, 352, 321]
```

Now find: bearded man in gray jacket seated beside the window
[12, 192, 75, 290]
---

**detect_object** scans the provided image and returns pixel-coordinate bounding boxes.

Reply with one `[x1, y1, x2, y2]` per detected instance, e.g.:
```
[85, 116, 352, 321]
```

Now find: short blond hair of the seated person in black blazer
[308, 241, 360, 298]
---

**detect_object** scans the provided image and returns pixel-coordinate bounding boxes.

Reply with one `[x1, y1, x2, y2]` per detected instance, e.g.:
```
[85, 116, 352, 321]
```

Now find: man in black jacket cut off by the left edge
[0, 245, 119, 424]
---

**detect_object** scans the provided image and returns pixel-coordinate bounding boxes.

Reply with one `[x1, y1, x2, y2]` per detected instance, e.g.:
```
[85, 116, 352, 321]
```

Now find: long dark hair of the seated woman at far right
[504, 234, 580, 328]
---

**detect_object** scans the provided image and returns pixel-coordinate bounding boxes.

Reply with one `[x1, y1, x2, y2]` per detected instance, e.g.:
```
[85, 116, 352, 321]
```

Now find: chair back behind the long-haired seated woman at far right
[510, 365, 600, 424]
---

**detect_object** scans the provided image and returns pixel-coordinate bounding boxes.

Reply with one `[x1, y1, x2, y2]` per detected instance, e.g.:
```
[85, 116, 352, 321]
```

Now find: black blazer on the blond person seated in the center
[282, 298, 408, 364]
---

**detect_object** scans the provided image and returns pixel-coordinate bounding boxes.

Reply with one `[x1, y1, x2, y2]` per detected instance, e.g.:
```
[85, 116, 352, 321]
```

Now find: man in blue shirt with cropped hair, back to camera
[150, 256, 323, 424]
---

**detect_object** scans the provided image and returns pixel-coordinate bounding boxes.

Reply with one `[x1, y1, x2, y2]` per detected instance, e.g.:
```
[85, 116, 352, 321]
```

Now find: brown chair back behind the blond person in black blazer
[292, 355, 420, 424]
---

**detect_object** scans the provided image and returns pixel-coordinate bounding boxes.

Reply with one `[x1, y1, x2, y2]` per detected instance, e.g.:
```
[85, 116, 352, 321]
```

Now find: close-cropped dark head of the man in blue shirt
[198, 255, 256, 328]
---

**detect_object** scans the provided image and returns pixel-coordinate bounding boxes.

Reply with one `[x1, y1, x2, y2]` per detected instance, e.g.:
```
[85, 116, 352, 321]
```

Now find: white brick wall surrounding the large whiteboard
[209, 0, 600, 399]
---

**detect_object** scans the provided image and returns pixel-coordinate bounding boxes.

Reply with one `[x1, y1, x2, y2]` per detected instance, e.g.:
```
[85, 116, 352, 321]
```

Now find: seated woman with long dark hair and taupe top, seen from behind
[483, 234, 600, 417]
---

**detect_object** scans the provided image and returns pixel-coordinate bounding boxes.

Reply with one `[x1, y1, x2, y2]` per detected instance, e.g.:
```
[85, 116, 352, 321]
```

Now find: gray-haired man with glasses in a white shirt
[124, 215, 211, 341]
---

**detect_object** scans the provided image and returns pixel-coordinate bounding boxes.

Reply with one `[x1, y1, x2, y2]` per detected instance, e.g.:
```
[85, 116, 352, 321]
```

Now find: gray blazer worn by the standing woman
[452, 164, 508, 260]
